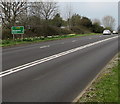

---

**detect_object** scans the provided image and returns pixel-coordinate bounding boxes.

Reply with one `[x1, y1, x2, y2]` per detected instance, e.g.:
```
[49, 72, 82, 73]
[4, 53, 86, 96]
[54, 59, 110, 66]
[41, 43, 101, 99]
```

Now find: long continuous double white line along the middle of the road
[0, 36, 118, 77]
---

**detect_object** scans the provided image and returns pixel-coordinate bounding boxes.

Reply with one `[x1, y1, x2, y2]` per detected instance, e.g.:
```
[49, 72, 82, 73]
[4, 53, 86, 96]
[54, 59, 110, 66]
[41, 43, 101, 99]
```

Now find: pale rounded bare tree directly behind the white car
[102, 16, 115, 30]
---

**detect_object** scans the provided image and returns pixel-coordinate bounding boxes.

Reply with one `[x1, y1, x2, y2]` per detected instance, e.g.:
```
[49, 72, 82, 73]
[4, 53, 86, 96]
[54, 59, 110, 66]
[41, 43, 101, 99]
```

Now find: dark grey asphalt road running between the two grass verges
[2, 35, 119, 102]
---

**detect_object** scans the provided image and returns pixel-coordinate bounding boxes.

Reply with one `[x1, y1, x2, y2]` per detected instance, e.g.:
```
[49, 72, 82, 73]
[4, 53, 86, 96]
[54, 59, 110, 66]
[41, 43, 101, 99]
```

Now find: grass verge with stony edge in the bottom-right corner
[78, 54, 120, 103]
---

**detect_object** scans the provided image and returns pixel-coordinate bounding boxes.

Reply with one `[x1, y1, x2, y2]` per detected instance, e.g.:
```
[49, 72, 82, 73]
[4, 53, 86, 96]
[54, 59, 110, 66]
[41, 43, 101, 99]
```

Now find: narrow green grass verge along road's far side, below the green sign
[0, 33, 99, 47]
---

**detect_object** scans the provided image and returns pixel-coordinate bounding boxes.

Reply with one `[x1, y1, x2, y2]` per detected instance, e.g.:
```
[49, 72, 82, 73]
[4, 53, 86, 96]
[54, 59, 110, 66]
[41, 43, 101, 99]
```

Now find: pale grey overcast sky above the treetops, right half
[59, 0, 118, 28]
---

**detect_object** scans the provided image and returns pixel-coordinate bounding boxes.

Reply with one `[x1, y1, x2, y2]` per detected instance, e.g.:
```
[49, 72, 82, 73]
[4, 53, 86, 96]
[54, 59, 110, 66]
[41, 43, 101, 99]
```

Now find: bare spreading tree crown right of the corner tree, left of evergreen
[29, 1, 58, 20]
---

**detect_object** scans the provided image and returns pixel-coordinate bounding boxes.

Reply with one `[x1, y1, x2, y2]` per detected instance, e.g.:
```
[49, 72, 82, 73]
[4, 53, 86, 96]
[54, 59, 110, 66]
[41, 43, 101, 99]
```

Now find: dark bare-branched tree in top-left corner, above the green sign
[0, 0, 27, 28]
